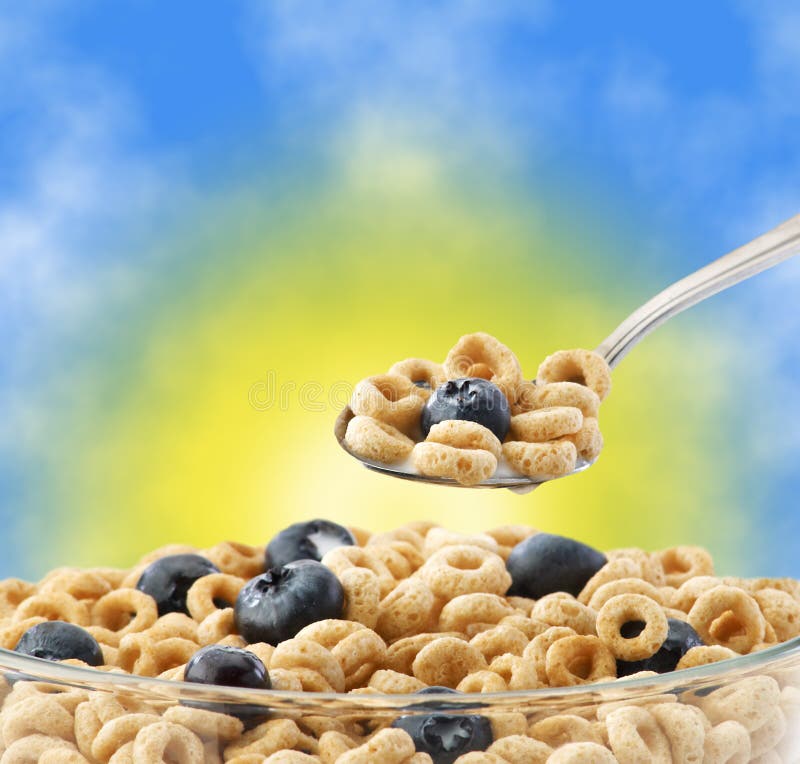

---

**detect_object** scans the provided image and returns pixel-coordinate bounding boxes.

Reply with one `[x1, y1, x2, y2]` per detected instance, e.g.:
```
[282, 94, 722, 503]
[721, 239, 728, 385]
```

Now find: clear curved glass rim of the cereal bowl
[0, 637, 800, 712]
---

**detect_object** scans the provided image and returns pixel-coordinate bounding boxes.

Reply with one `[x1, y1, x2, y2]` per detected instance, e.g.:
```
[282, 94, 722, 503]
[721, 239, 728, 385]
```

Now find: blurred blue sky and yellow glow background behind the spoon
[0, 0, 800, 577]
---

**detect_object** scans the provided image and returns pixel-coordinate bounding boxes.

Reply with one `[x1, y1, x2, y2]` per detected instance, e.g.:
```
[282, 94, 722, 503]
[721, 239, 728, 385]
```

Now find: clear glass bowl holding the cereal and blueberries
[0, 638, 800, 764]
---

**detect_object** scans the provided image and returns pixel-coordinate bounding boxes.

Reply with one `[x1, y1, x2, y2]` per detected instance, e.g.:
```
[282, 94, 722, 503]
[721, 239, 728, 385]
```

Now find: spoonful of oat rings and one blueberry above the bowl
[344, 332, 611, 485]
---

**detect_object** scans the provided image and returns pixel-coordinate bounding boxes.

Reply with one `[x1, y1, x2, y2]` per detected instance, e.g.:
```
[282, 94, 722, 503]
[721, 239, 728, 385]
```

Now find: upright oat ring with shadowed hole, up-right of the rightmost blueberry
[689, 586, 766, 655]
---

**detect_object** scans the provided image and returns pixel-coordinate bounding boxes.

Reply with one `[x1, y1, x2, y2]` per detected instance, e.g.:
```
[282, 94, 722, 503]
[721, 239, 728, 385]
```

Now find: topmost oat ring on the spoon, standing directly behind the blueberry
[444, 332, 524, 401]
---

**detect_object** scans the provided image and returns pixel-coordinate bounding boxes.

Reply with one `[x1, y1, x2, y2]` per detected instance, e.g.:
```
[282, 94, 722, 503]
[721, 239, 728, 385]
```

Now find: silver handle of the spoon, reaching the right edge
[597, 215, 800, 368]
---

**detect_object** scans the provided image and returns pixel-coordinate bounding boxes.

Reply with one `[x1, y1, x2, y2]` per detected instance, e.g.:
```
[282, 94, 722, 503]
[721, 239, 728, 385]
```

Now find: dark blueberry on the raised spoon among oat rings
[421, 377, 511, 441]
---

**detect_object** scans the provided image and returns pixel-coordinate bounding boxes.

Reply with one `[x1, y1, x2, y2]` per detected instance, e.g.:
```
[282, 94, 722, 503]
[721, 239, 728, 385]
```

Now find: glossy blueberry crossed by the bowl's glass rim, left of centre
[182, 645, 272, 726]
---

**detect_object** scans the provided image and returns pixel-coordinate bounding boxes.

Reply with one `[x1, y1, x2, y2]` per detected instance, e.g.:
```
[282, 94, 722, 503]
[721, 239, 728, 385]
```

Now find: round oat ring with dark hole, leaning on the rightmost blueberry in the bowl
[597, 594, 669, 661]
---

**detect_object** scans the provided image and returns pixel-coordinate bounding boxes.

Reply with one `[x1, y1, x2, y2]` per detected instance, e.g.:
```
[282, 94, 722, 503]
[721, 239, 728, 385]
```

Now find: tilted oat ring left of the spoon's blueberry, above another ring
[350, 374, 430, 435]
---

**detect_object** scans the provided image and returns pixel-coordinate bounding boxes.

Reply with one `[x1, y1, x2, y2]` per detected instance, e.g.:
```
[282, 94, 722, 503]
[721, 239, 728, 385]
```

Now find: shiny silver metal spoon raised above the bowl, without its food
[334, 214, 800, 493]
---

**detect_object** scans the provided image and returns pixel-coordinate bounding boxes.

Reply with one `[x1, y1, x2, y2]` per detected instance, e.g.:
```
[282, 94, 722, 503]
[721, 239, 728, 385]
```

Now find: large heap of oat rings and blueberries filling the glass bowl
[0, 520, 800, 764]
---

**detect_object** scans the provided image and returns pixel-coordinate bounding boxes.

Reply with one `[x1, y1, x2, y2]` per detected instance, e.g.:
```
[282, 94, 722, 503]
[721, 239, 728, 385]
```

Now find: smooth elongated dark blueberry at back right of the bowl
[506, 533, 606, 599]
